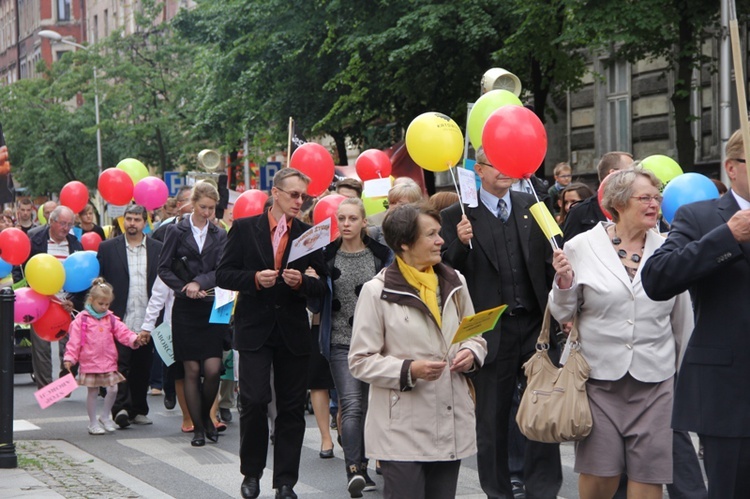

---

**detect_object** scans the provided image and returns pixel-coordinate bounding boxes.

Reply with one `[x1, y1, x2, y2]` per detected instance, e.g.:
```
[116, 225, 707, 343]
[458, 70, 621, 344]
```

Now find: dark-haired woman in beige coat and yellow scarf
[349, 205, 487, 499]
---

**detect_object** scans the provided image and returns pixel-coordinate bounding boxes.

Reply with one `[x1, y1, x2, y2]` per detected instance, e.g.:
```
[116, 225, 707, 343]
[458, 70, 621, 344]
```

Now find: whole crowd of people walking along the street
[11, 132, 750, 499]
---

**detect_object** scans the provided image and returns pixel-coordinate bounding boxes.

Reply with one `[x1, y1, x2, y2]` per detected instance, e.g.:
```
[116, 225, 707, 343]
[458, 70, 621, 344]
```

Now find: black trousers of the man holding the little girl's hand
[112, 341, 154, 419]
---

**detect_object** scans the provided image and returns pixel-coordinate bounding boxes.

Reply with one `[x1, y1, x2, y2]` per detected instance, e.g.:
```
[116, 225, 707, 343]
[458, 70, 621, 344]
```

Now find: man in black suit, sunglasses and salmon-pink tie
[216, 168, 327, 499]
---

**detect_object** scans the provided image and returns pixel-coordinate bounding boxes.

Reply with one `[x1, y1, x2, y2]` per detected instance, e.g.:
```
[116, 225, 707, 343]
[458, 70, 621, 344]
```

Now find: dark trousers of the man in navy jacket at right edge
[700, 435, 750, 499]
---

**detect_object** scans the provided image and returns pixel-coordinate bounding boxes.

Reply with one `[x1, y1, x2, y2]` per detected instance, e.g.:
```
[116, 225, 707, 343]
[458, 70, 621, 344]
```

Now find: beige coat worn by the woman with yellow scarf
[349, 264, 487, 462]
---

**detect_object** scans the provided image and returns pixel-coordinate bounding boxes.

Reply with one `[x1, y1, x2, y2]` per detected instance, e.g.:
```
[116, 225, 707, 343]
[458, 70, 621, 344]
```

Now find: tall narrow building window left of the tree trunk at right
[605, 61, 631, 151]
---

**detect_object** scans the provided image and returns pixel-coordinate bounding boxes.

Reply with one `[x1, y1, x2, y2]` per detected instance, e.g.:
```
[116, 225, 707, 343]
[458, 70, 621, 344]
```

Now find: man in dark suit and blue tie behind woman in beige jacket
[440, 148, 562, 499]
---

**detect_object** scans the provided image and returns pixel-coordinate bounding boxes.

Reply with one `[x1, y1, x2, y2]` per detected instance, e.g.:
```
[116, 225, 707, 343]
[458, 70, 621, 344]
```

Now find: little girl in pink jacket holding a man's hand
[63, 277, 144, 435]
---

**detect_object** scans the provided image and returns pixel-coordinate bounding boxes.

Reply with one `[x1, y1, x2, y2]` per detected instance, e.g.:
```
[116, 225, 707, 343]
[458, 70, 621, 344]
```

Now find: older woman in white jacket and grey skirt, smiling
[549, 167, 693, 499]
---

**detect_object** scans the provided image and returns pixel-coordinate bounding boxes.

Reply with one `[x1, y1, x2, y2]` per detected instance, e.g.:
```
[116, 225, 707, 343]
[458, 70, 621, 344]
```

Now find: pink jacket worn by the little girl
[64, 310, 138, 374]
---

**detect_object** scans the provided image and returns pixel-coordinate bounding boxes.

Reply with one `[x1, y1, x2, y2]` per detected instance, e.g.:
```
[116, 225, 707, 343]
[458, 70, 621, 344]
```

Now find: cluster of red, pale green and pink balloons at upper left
[98, 158, 169, 212]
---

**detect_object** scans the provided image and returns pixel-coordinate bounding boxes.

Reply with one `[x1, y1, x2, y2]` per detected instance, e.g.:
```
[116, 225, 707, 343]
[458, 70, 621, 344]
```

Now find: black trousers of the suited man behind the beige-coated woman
[474, 314, 563, 499]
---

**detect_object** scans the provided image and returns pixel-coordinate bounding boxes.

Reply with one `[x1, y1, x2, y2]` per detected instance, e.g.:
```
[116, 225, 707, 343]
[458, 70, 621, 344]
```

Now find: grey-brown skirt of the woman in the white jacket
[575, 373, 674, 484]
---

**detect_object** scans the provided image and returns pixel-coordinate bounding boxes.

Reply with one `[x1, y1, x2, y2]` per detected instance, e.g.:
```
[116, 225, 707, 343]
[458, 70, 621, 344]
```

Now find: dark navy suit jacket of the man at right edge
[641, 193, 750, 438]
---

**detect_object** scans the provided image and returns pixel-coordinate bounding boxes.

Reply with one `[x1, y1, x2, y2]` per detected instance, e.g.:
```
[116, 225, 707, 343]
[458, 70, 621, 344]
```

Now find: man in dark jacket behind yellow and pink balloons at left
[13, 203, 86, 388]
